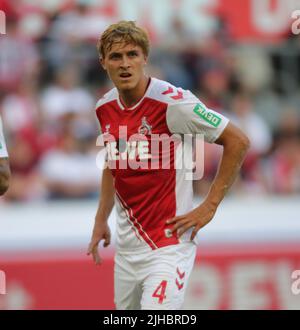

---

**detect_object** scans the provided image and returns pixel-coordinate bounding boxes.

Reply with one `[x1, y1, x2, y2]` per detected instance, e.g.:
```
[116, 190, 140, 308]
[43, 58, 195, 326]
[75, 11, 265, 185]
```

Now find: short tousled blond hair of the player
[97, 21, 149, 58]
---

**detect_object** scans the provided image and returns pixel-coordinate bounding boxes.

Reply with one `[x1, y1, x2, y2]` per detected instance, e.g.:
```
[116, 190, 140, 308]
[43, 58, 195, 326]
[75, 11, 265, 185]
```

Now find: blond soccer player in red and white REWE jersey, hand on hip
[87, 21, 249, 309]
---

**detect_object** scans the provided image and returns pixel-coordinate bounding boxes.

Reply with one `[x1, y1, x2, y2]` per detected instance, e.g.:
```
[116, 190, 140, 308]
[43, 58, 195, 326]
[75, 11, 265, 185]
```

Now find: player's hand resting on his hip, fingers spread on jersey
[167, 202, 216, 240]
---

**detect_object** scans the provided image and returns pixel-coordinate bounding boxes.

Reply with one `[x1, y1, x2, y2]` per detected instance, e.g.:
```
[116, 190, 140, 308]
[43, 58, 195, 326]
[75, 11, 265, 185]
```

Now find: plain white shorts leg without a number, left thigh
[114, 254, 142, 310]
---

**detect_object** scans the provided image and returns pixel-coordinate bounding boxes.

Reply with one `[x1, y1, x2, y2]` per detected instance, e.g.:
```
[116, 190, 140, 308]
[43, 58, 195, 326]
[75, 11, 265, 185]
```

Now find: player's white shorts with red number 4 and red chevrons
[114, 242, 196, 310]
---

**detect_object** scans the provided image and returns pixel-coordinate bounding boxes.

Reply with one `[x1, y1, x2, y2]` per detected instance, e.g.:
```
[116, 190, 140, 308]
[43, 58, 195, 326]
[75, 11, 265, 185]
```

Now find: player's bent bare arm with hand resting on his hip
[167, 122, 250, 239]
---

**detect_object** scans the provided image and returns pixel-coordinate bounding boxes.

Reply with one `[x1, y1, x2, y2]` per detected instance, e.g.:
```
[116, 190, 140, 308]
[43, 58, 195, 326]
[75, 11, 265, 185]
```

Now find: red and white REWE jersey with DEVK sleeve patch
[96, 78, 228, 252]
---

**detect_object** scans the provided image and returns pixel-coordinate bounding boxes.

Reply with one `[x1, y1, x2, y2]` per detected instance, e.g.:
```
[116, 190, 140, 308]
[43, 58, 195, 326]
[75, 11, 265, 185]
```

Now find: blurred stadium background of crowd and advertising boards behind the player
[0, 0, 300, 309]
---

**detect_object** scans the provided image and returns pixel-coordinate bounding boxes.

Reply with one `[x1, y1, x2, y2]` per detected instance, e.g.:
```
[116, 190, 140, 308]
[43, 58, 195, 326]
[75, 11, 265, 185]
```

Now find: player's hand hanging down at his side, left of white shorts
[87, 223, 111, 265]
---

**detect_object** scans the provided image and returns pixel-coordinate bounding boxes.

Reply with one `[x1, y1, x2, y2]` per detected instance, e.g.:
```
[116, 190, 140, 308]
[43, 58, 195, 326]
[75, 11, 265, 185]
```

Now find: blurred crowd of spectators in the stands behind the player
[0, 0, 300, 202]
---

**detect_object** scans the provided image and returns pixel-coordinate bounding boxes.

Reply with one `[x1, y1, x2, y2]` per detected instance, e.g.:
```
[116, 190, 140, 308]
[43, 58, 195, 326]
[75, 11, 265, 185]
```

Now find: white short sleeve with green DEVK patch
[166, 91, 229, 143]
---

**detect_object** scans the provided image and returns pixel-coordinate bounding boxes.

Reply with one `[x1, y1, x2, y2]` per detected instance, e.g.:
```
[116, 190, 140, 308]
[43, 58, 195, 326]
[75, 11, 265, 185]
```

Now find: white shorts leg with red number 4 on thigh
[141, 244, 196, 310]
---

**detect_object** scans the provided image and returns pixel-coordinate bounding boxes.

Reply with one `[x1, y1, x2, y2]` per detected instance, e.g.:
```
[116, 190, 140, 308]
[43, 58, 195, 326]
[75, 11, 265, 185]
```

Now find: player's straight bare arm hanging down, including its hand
[87, 167, 115, 265]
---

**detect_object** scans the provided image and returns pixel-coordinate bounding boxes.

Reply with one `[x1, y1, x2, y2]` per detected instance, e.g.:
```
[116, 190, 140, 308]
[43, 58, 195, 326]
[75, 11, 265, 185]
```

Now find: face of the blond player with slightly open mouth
[101, 43, 147, 91]
